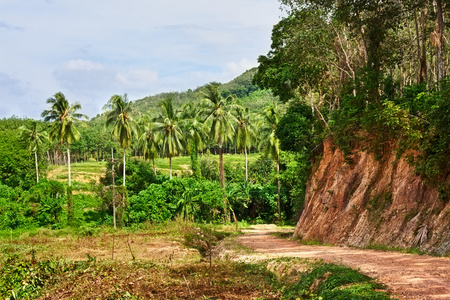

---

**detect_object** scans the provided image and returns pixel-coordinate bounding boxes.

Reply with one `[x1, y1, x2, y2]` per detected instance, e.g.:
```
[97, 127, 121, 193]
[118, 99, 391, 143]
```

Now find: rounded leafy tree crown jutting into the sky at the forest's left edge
[253, 10, 336, 102]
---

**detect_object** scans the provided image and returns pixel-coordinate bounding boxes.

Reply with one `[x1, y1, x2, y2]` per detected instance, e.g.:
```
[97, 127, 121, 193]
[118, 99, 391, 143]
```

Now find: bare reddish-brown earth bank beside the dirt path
[294, 139, 450, 254]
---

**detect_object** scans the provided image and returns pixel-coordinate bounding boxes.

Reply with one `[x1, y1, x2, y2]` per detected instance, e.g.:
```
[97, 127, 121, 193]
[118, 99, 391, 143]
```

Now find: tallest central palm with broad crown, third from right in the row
[201, 82, 237, 188]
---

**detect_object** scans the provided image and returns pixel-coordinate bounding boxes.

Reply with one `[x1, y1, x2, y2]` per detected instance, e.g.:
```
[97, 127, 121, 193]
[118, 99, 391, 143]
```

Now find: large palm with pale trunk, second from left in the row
[42, 92, 88, 186]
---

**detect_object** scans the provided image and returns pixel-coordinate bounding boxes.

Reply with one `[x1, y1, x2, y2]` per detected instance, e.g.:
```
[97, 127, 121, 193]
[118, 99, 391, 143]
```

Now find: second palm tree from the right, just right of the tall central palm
[236, 107, 256, 181]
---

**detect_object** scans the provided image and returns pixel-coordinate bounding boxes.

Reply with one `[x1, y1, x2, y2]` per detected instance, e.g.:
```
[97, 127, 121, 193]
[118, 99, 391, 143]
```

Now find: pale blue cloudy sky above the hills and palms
[0, 0, 283, 119]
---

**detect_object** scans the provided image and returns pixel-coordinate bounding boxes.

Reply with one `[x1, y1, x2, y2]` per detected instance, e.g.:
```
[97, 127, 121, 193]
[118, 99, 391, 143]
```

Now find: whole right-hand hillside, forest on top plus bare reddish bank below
[255, 0, 450, 253]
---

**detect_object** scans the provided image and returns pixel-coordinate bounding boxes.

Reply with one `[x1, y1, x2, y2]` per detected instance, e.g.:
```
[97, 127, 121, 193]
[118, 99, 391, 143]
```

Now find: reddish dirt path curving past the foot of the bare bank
[237, 225, 450, 300]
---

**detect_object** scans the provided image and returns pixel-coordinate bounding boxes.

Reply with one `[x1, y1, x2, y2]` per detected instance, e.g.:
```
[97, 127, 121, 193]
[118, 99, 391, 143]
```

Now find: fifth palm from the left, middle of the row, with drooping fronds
[155, 98, 184, 179]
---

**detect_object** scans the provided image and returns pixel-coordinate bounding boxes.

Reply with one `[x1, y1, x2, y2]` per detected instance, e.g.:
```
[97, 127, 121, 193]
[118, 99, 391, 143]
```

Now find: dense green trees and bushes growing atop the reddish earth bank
[254, 0, 450, 195]
